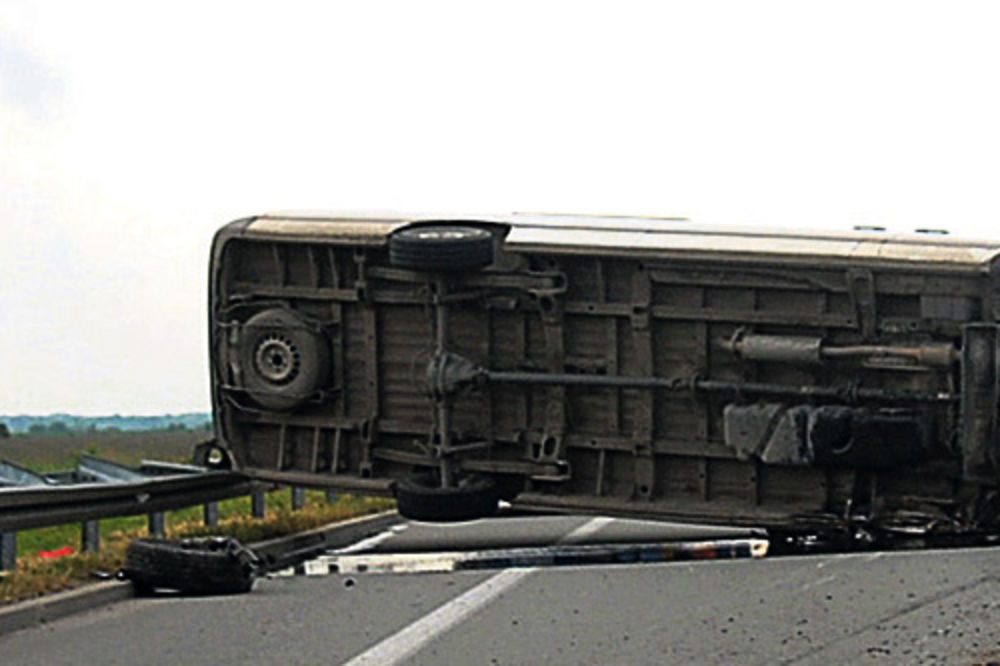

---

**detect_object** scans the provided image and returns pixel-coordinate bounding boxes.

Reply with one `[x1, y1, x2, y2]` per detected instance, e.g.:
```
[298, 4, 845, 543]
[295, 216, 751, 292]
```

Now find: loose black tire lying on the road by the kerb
[122, 537, 256, 594]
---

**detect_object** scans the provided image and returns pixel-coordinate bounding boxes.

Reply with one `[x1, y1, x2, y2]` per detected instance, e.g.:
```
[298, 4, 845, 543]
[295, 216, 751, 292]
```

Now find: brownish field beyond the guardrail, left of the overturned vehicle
[0, 430, 206, 472]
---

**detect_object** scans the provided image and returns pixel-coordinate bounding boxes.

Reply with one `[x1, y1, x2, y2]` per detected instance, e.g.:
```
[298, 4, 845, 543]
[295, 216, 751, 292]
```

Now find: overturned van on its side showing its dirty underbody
[209, 214, 1000, 533]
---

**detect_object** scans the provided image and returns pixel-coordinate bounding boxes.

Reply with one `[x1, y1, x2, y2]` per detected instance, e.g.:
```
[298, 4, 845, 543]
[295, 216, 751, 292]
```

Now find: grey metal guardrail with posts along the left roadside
[0, 456, 335, 570]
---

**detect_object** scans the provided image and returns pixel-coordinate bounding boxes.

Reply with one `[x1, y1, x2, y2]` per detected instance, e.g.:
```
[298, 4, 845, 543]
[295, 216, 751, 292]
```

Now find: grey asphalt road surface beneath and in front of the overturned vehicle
[0, 517, 1000, 666]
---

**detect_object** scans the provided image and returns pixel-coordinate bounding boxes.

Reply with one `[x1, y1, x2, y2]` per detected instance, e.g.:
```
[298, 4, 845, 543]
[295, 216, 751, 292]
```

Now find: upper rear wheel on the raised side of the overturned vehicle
[389, 224, 493, 273]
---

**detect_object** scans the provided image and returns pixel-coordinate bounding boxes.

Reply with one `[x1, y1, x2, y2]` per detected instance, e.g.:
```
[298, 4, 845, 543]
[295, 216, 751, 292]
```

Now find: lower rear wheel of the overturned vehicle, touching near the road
[393, 473, 500, 522]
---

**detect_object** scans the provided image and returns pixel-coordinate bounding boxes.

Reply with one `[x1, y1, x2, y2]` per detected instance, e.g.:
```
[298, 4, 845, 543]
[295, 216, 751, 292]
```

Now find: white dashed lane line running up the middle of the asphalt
[344, 516, 614, 666]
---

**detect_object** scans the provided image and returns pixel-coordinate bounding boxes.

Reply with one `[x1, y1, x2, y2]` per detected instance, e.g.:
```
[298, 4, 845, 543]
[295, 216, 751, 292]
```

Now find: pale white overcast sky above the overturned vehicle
[0, 0, 1000, 414]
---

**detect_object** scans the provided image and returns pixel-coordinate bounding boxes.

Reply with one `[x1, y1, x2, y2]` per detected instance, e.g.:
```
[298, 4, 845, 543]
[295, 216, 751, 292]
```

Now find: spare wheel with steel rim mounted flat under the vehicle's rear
[239, 308, 331, 410]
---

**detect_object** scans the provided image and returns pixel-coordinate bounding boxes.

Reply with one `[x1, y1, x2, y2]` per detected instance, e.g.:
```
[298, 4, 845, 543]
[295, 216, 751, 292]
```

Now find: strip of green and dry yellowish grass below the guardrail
[0, 491, 393, 606]
